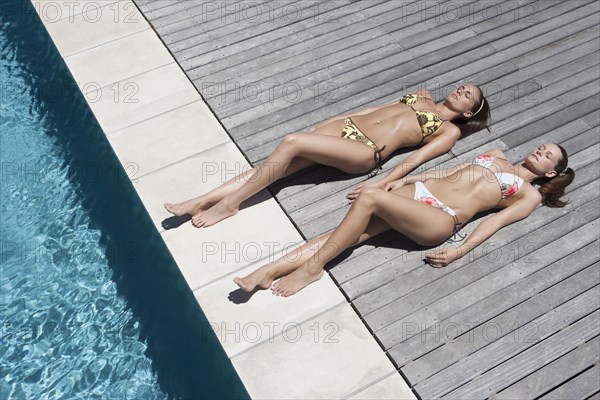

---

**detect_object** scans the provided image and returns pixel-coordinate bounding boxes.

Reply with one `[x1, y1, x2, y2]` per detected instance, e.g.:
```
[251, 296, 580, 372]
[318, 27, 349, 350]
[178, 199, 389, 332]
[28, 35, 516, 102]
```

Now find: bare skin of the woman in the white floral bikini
[234, 144, 561, 297]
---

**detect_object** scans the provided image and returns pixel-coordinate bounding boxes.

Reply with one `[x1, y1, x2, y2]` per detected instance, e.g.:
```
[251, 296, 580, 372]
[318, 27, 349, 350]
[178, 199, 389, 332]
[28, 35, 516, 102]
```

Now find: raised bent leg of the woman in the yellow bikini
[192, 120, 374, 227]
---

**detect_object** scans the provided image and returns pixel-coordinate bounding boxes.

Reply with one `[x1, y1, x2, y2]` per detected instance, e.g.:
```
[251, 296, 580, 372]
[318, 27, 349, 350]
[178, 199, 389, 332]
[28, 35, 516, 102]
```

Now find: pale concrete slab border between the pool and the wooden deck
[31, 0, 415, 398]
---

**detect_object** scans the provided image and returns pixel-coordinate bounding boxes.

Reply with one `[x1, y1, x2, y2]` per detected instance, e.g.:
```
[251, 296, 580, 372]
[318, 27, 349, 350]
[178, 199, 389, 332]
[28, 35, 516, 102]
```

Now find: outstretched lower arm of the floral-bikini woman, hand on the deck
[425, 189, 542, 267]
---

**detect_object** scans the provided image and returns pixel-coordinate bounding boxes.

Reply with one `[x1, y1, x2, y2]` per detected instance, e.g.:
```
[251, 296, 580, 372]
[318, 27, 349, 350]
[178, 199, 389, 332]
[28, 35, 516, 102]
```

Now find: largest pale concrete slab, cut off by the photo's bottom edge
[231, 299, 395, 399]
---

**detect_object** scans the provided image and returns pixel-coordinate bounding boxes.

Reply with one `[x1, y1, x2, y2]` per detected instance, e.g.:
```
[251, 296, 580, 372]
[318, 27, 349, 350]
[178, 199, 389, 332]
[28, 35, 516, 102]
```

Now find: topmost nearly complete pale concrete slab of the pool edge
[40, 1, 151, 57]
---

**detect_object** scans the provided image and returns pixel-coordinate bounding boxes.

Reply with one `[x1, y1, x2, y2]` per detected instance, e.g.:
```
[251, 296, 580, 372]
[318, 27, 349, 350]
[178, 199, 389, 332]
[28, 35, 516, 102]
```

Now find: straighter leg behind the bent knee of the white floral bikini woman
[233, 216, 391, 292]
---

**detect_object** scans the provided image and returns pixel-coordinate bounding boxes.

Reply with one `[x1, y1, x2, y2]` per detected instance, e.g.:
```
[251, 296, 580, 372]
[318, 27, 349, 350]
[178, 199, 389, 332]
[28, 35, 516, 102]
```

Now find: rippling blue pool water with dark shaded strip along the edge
[0, 0, 248, 400]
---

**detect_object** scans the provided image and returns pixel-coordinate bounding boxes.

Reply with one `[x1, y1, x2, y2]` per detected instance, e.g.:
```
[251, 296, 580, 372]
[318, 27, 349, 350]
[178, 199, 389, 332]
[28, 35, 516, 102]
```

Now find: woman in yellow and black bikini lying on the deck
[163, 85, 490, 229]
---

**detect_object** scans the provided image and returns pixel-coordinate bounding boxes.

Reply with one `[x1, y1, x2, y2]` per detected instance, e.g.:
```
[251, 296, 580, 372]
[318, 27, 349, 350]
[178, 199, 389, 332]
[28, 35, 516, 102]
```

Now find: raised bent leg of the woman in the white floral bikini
[272, 185, 454, 296]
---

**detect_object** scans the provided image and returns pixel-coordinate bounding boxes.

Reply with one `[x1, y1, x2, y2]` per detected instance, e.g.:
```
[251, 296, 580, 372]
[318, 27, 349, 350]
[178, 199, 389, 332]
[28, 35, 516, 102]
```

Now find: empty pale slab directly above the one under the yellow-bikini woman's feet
[108, 100, 231, 179]
